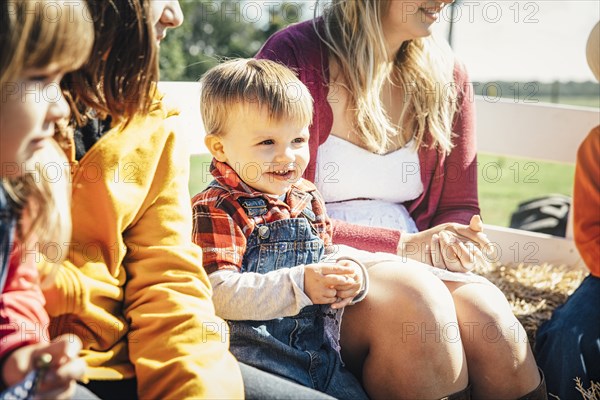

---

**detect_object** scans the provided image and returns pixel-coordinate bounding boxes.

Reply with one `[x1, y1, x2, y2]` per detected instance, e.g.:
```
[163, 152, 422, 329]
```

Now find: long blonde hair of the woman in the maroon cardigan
[315, 0, 459, 153]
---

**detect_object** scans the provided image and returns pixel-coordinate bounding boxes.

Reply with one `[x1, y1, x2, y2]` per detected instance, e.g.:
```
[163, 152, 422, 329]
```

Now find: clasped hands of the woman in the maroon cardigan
[398, 215, 491, 272]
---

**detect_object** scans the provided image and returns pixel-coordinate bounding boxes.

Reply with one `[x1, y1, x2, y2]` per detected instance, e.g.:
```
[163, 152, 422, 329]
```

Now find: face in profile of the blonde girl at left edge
[0, 65, 69, 176]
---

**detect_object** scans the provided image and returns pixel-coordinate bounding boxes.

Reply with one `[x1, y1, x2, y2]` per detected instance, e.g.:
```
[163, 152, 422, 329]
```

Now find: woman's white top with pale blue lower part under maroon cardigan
[315, 135, 423, 232]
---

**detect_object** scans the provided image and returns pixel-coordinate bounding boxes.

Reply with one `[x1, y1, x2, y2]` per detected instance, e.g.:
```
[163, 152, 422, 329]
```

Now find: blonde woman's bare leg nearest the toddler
[341, 262, 468, 399]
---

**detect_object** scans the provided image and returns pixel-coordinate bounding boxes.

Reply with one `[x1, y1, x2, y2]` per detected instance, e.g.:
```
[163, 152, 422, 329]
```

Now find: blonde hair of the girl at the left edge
[0, 0, 94, 268]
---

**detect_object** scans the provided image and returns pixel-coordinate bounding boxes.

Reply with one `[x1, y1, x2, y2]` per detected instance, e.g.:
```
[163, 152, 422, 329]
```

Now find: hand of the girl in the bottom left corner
[2, 334, 86, 399]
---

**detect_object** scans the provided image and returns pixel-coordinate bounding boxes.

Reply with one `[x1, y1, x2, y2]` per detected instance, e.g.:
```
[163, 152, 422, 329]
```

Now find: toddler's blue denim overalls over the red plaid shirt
[228, 192, 367, 399]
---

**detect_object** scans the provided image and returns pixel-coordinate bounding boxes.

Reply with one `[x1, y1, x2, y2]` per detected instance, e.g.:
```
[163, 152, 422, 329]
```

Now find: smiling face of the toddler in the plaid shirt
[206, 107, 310, 196]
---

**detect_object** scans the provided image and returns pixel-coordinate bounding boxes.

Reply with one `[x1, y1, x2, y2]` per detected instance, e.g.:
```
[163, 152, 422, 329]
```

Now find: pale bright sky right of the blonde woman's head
[434, 0, 600, 82]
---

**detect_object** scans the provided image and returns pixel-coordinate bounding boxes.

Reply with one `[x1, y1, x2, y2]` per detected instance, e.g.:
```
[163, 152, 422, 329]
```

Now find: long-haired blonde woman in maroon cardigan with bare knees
[257, 0, 544, 398]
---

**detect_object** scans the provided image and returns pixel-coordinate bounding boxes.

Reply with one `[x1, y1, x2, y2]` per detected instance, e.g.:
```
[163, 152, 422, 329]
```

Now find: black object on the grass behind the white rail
[510, 194, 571, 237]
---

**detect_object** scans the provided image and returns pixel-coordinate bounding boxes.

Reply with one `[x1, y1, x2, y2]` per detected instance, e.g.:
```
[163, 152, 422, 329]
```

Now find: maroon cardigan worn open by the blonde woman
[256, 18, 479, 253]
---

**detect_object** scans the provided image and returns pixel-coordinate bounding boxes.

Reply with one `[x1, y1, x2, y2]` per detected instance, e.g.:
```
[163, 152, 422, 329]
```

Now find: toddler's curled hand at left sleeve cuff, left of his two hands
[304, 263, 355, 308]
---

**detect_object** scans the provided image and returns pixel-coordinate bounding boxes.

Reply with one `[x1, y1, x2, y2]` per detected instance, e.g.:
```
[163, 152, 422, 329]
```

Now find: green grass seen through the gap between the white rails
[189, 154, 575, 226]
